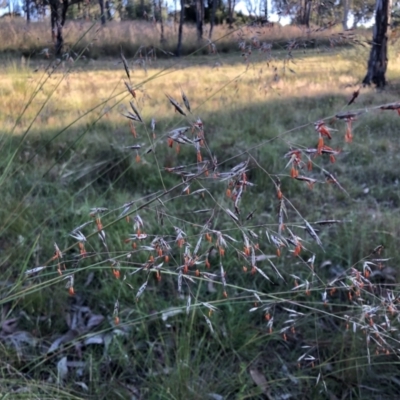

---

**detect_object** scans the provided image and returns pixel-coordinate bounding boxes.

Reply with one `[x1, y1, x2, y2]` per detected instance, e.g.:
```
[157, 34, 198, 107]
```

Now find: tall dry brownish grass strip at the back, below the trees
[0, 18, 369, 58]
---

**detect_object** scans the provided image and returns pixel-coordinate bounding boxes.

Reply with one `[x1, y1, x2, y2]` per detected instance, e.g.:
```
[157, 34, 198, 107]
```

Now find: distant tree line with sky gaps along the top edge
[16, 0, 399, 37]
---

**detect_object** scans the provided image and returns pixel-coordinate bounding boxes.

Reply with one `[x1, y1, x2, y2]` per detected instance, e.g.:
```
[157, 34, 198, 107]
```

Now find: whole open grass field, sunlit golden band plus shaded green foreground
[0, 24, 400, 399]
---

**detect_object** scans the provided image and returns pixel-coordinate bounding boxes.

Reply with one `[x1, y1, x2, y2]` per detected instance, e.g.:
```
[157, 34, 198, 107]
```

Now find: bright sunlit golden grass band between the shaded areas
[0, 45, 400, 138]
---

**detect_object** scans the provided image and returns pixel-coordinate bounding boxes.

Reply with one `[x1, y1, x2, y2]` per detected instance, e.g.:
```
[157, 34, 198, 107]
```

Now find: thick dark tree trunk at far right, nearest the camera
[362, 0, 391, 88]
